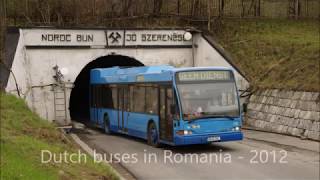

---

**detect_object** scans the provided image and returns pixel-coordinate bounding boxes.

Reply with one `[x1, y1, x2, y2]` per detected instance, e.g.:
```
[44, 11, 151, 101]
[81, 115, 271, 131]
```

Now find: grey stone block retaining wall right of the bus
[244, 89, 320, 141]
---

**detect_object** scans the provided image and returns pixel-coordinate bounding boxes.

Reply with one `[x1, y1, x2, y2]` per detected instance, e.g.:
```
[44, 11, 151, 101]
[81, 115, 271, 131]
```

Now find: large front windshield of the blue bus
[177, 72, 240, 120]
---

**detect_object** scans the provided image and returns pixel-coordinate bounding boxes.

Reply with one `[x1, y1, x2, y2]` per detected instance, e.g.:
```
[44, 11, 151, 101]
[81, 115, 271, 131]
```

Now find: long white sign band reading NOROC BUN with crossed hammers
[23, 29, 192, 48]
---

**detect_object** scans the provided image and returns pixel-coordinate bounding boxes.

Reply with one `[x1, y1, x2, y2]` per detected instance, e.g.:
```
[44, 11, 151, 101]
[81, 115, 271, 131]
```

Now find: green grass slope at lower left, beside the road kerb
[0, 93, 118, 179]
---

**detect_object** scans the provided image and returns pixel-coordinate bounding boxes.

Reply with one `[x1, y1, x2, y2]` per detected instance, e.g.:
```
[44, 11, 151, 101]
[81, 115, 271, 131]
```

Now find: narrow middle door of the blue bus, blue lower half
[118, 85, 129, 131]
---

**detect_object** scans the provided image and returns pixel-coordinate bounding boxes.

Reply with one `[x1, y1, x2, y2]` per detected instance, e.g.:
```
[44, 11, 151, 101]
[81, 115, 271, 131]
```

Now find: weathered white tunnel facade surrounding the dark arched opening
[5, 28, 248, 124]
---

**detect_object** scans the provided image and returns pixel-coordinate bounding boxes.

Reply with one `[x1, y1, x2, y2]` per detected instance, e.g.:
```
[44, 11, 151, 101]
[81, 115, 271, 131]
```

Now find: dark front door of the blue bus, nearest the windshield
[159, 86, 173, 141]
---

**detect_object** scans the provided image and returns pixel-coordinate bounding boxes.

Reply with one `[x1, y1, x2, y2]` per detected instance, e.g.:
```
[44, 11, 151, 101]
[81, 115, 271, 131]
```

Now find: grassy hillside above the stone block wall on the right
[213, 19, 320, 91]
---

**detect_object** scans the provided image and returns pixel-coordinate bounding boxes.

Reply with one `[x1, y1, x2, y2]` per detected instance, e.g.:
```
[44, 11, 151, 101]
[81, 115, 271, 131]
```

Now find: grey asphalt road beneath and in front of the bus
[77, 126, 319, 180]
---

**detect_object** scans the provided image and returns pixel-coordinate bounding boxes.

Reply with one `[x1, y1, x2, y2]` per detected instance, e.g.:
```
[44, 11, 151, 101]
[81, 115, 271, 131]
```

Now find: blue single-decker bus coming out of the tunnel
[90, 66, 243, 147]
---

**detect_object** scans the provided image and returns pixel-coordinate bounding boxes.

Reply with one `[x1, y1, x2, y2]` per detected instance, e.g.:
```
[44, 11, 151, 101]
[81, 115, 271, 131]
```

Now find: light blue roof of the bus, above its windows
[90, 65, 232, 84]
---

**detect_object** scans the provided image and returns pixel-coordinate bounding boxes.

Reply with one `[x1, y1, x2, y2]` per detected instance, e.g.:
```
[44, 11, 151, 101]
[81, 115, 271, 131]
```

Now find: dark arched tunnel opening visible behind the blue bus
[69, 55, 144, 122]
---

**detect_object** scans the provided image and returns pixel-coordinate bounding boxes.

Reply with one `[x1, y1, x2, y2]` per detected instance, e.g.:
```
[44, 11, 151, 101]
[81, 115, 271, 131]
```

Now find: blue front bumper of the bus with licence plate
[174, 131, 243, 145]
